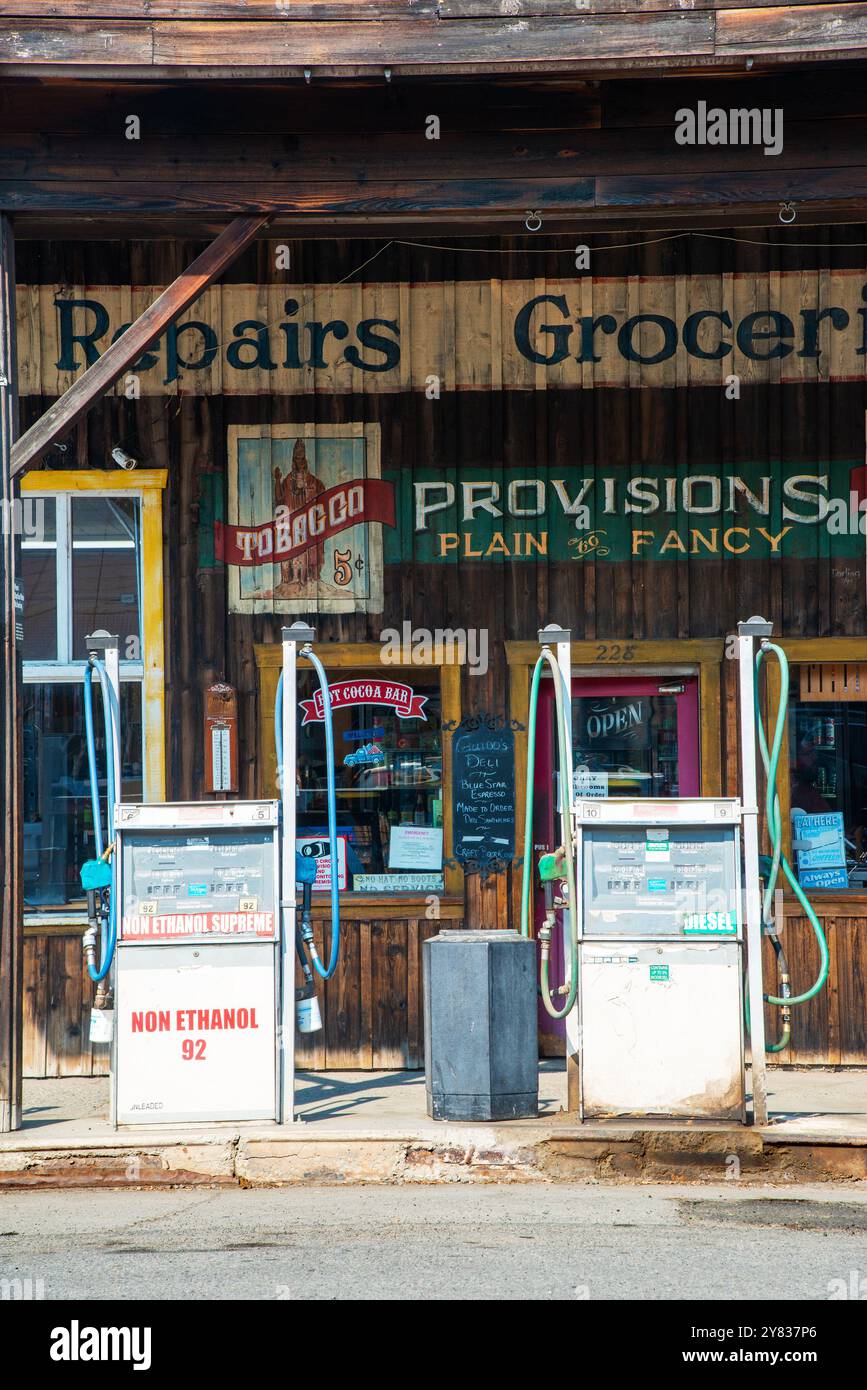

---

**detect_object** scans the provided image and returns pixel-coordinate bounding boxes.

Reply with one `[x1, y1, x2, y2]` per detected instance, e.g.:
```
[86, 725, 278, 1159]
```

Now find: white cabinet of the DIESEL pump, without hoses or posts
[565, 798, 746, 1120]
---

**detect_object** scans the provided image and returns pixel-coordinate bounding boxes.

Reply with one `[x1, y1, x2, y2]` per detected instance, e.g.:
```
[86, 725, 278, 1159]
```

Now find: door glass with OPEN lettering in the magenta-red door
[572, 695, 679, 798]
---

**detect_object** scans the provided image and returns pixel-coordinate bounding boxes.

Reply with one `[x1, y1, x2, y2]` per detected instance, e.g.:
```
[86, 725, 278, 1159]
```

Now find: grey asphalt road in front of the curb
[0, 1183, 867, 1301]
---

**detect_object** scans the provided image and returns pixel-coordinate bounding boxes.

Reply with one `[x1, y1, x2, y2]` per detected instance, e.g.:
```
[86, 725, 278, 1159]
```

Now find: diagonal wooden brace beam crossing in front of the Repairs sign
[11, 215, 268, 477]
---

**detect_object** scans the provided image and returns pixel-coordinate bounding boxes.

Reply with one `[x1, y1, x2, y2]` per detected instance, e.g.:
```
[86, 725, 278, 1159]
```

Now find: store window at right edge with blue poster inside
[789, 663, 867, 891]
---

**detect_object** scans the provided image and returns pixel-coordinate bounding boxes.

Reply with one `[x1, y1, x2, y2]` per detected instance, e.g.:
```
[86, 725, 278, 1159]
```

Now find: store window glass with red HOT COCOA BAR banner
[297, 670, 443, 894]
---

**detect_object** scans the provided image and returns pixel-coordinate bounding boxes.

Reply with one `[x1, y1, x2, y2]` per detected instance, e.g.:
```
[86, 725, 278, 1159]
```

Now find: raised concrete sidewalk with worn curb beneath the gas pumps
[0, 1062, 867, 1187]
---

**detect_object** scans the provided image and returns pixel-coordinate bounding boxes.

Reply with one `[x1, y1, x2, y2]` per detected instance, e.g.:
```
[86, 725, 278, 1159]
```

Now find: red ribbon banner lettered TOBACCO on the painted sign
[214, 478, 395, 566]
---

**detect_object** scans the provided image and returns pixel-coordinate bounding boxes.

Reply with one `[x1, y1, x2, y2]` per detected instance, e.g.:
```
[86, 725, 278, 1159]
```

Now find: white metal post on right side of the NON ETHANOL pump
[278, 623, 315, 1125]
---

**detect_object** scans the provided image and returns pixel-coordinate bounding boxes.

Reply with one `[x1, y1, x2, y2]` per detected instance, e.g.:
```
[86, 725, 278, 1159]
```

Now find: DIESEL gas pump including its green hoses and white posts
[521, 617, 828, 1125]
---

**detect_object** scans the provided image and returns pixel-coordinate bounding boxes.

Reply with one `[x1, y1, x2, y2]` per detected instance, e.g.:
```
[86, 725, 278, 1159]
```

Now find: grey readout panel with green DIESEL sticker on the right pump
[582, 824, 739, 937]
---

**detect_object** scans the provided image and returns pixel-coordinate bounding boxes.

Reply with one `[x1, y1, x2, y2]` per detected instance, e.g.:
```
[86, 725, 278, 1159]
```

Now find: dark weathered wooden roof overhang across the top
[0, 0, 867, 239]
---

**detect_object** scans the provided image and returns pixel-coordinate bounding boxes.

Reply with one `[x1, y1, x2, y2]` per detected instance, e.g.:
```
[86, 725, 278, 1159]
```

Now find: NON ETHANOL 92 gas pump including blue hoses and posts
[81, 623, 340, 1126]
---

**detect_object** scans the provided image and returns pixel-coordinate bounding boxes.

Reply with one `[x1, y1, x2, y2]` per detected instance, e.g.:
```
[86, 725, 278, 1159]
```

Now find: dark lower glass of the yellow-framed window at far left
[22, 681, 142, 908]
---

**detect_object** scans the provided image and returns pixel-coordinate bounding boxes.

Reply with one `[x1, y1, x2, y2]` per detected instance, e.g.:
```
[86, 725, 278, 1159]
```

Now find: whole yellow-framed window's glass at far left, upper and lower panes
[22, 491, 145, 909]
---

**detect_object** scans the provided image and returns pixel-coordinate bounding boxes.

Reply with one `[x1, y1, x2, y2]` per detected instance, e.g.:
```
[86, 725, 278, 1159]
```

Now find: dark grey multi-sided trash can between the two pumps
[424, 931, 539, 1120]
